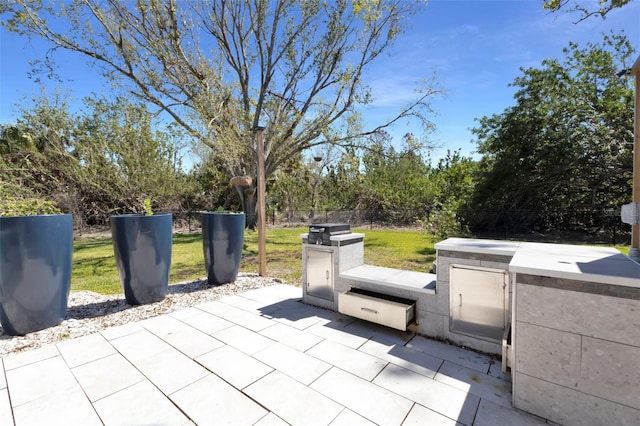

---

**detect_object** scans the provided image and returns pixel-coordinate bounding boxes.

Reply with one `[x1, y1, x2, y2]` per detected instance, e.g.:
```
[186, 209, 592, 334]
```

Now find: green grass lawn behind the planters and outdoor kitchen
[71, 227, 629, 294]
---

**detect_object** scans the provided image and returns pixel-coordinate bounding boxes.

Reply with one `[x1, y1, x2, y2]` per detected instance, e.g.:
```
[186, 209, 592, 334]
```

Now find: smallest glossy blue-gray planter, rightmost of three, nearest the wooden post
[202, 213, 245, 285]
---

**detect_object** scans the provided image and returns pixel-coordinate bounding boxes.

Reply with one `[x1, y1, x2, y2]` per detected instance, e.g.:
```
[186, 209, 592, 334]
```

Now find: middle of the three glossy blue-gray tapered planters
[111, 214, 173, 305]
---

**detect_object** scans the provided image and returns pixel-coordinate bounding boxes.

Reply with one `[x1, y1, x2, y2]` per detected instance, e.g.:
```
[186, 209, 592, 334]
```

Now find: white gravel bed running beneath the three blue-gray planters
[0, 273, 282, 357]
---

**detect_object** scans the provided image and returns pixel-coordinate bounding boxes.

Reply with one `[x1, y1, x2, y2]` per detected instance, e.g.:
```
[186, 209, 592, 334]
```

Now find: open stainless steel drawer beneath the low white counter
[338, 288, 416, 331]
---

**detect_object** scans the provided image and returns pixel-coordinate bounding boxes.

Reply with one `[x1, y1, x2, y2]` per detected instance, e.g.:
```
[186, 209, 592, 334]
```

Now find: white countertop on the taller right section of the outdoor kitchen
[435, 238, 640, 288]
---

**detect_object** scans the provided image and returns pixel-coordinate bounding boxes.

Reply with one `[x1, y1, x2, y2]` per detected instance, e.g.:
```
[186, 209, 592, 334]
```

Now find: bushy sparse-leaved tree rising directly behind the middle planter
[74, 98, 194, 213]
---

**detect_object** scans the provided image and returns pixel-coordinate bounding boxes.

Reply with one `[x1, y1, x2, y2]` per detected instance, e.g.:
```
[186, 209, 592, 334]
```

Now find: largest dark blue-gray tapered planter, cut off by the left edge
[0, 214, 73, 336]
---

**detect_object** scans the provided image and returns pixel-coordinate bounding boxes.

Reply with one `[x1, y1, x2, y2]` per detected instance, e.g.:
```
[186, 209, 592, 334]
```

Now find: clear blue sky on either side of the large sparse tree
[0, 0, 640, 163]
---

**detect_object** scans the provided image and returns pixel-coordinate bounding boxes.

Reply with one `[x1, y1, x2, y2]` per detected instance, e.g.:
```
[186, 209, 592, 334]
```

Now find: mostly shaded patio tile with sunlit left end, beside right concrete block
[435, 361, 512, 408]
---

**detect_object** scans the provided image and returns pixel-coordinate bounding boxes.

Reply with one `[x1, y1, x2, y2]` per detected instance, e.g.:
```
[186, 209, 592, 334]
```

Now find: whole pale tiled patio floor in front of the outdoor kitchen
[0, 285, 544, 426]
